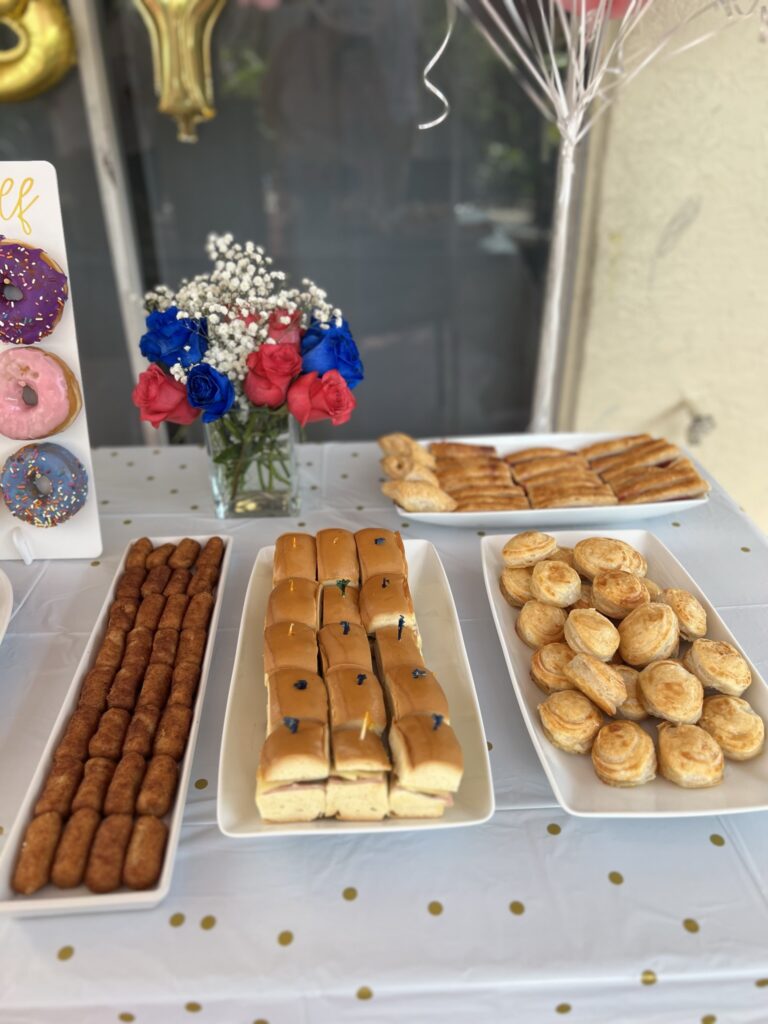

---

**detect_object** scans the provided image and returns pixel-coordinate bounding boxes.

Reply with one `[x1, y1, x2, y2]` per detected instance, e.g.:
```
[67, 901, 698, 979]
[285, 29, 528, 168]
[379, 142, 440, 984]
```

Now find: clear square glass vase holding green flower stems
[205, 406, 299, 519]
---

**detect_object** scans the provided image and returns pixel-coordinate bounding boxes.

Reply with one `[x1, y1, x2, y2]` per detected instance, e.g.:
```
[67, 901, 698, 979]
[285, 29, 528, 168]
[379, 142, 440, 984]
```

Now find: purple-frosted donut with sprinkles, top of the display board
[0, 234, 69, 345]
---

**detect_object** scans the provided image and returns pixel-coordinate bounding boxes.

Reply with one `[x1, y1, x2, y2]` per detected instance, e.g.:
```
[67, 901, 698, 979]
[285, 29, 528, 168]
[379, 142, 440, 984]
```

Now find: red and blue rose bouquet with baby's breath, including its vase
[133, 234, 364, 518]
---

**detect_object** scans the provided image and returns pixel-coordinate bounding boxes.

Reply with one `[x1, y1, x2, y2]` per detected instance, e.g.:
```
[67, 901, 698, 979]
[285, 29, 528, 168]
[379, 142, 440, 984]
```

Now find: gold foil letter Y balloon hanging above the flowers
[133, 0, 226, 142]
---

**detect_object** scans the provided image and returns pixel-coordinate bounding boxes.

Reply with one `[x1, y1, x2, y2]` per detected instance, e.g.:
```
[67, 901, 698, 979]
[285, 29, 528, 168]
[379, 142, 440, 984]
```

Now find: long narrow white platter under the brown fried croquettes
[0, 536, 231, 918]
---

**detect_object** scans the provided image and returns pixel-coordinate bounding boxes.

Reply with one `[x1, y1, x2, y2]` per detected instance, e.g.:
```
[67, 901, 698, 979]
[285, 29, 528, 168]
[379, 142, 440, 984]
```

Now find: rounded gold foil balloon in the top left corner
[0, 0, 76, 103]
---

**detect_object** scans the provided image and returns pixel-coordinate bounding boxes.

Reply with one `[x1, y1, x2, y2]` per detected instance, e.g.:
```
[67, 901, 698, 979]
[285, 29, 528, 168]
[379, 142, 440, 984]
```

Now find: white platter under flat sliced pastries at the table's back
[397, 434, 708, 530]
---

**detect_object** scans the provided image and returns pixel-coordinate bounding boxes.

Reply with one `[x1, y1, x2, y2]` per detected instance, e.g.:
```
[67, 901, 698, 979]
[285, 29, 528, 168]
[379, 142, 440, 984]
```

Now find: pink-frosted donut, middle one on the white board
[0, 346, 83, 440]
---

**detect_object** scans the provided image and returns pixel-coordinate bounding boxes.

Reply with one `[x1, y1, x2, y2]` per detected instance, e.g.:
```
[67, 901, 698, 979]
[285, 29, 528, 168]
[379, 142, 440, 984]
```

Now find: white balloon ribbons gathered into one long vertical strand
[456, 0, 766, 431]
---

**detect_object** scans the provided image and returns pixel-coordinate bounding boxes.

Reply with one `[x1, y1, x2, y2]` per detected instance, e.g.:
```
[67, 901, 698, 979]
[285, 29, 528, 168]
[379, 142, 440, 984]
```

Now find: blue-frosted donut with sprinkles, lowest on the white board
[0, 443, 88, 527]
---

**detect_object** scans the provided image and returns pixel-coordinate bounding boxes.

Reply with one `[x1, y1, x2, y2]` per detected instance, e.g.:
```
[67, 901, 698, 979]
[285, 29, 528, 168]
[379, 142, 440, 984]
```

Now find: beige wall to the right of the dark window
[560, 0, 768, 529]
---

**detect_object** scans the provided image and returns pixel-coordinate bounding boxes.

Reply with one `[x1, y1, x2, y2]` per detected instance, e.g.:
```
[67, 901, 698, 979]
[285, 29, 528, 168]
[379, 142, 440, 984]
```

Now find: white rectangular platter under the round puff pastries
[482, 529, 768, 818]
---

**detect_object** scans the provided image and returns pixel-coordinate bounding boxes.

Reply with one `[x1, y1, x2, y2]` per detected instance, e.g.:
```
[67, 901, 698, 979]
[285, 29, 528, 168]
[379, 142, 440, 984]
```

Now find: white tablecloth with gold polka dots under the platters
[0, 444, 768, 1024]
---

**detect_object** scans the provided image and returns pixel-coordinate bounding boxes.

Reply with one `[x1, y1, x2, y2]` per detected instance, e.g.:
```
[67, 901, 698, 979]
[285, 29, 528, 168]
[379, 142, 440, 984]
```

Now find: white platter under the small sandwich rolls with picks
[216, 541, 494, 839]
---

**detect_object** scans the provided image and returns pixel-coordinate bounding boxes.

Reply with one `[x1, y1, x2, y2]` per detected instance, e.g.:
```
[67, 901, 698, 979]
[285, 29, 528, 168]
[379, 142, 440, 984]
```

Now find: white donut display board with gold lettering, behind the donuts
[0, 161, 101, 560]
